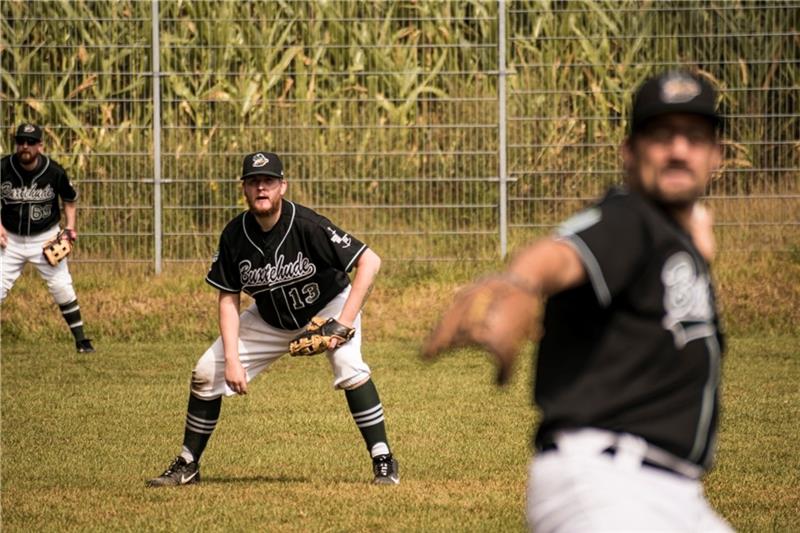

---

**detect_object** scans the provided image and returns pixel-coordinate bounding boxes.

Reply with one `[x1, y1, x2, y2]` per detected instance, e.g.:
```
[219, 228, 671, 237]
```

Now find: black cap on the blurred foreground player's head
[630, 70, 722, 133]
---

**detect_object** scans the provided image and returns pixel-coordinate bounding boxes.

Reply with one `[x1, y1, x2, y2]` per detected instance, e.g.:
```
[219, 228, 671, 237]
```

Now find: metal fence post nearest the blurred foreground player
[497, 0, 508, 259]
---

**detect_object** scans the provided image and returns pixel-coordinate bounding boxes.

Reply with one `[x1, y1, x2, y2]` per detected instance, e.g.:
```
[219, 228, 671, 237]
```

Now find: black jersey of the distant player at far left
[0, 154, 78, 235]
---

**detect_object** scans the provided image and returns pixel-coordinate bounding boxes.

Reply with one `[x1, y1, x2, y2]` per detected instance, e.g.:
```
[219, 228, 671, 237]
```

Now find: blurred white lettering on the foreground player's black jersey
[661, 252, 716, 348]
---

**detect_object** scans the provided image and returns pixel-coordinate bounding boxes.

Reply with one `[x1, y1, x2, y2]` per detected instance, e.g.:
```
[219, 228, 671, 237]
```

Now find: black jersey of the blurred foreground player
[535, 185, 723, 467]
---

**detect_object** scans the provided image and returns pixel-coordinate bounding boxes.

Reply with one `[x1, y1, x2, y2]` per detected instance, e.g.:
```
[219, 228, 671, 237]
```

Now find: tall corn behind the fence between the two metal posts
[161, 2, 496, 262]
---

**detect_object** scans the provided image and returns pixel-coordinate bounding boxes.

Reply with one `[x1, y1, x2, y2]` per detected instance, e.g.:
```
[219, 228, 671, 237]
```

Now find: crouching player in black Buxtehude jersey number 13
[149, 152, 400, 486]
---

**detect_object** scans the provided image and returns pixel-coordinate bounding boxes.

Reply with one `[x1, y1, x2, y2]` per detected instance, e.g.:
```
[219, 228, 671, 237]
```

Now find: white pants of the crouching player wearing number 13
[192, 286, 370, 400]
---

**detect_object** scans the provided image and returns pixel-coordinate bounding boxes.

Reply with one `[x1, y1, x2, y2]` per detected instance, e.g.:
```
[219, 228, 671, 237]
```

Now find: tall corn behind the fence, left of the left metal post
[0, 0, 152, 257]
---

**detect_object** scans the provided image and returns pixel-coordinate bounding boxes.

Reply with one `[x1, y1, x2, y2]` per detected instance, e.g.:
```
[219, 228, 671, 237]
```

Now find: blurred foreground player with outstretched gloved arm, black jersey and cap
[424, 71, 730, 532]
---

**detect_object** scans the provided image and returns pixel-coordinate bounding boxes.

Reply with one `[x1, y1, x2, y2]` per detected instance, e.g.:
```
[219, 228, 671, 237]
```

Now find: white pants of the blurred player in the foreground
[527, 429, 733, 533]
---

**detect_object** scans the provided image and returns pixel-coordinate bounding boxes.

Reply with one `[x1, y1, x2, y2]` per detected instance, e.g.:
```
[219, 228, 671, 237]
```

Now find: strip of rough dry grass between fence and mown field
[0, 241, 800, 343]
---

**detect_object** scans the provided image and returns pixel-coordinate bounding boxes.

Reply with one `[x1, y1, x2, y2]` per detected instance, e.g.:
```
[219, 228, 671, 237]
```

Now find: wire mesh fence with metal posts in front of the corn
[0, 0, 800, 270]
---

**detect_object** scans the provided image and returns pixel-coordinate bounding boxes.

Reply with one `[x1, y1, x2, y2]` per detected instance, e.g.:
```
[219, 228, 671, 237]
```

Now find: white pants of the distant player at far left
[0, 225, 77, 305]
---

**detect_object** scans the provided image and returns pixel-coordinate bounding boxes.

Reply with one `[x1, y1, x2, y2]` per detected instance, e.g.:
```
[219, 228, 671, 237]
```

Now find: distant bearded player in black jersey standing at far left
[0, 124, 94, 353]
